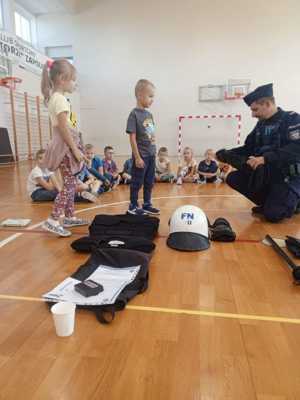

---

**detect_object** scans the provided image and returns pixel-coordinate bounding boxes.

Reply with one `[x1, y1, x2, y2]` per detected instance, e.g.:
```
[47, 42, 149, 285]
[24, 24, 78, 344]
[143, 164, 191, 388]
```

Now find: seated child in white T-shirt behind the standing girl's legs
[27, 149, 94, 203]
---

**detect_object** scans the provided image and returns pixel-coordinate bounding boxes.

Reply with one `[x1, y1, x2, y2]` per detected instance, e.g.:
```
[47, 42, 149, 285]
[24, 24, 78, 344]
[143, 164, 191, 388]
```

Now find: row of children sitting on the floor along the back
[27, 144, 230, 203]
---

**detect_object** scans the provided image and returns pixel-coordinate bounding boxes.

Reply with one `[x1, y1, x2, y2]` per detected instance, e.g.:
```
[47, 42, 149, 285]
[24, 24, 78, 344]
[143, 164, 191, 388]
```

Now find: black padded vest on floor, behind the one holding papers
[71, 213, 159, 252]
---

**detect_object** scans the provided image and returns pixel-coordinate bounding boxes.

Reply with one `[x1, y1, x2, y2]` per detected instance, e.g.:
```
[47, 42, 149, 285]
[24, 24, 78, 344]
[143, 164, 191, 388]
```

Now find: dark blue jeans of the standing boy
[130, 156, 155, 205]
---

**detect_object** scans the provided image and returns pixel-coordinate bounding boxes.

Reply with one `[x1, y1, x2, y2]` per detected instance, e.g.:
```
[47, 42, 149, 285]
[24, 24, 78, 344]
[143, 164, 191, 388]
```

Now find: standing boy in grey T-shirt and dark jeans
[126, 79, 160, 215]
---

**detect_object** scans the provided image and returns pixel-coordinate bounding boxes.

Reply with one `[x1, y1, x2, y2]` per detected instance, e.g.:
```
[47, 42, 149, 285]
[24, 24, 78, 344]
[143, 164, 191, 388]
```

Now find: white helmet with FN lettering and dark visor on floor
[167, 206, 210, 251]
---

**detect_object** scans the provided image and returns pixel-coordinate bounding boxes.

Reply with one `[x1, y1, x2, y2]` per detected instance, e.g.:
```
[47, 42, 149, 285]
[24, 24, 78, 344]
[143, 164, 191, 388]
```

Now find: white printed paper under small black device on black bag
[43, 265, 141, 305]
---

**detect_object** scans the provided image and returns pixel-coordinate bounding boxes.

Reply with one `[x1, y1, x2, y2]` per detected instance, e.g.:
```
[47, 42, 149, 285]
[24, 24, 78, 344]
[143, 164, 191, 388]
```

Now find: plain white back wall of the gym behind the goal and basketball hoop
[37, 0, 300, 155]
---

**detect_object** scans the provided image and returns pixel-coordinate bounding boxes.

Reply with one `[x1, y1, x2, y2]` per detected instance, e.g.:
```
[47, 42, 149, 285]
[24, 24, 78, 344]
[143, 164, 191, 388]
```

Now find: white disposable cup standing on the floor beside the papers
[51, 302, 76, 337]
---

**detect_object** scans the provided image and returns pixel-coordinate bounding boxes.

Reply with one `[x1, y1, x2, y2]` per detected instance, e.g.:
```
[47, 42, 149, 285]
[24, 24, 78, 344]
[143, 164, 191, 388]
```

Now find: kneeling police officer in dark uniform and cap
[221, 83, 300, 222]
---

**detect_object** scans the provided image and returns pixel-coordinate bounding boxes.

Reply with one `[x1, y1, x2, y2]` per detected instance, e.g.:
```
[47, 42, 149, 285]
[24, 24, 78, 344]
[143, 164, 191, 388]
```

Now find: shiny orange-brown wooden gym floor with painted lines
[0, 158, 300, 400]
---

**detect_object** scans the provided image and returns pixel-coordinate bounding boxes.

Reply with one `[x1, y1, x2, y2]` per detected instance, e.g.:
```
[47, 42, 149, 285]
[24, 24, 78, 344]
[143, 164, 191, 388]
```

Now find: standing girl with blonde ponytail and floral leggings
[41, 58, 90, 237]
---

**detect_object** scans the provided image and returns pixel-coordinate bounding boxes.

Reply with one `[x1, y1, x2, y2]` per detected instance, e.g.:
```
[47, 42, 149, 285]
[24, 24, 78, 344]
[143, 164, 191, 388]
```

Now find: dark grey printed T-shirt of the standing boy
[126, 108, 156, 157]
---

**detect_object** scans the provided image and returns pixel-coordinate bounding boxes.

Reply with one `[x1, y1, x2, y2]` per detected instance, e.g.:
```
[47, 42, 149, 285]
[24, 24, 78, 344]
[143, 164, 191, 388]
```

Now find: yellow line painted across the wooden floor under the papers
[0, 294, 300, 324]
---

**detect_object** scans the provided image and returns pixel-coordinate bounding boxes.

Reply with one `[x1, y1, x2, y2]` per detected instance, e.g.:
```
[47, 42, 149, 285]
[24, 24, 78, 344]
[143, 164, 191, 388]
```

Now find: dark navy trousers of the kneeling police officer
[226, 171, 299, 222]
